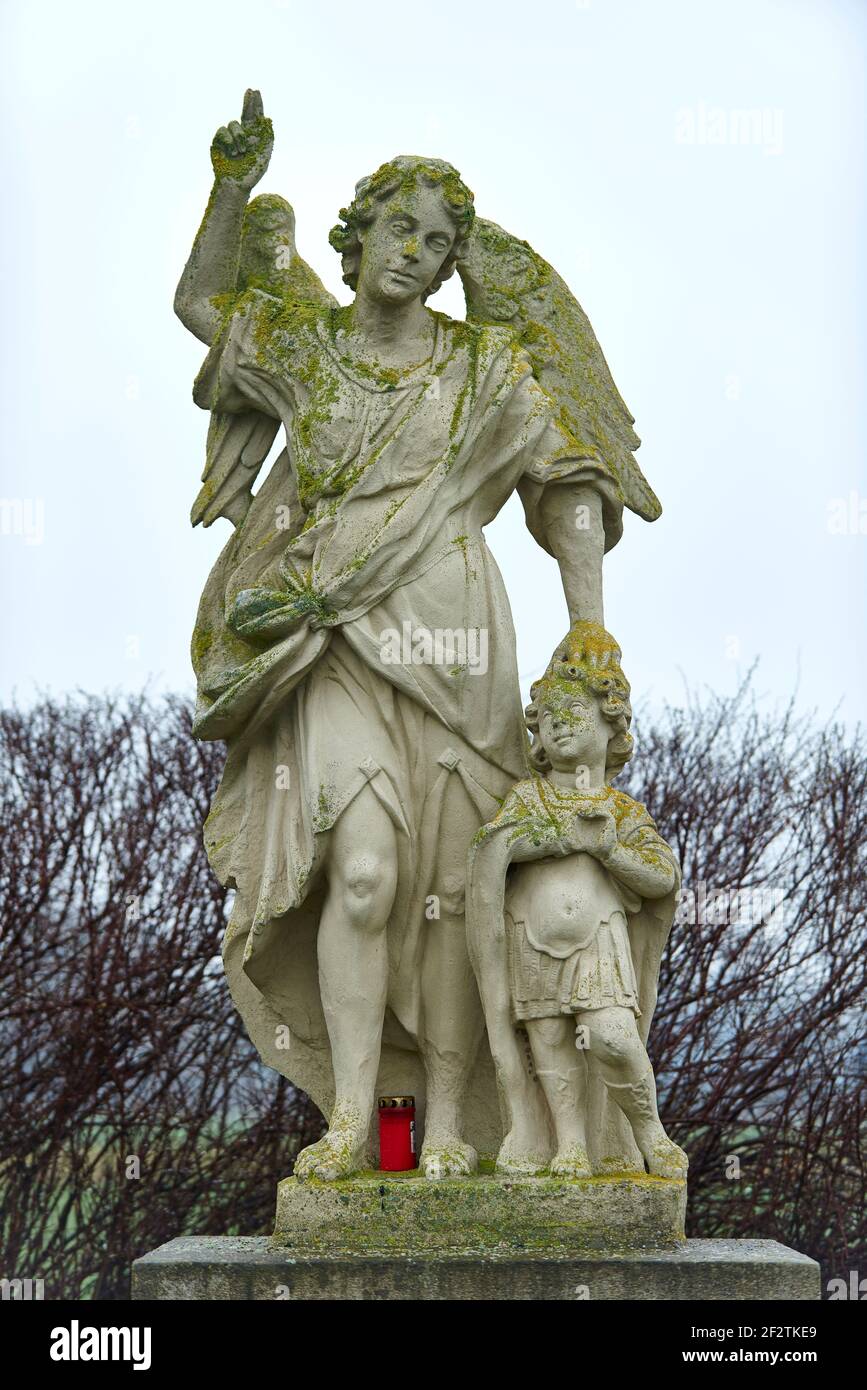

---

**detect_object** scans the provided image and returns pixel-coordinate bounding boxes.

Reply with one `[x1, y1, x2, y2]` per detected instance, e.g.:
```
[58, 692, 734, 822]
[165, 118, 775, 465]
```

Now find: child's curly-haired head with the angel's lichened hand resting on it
[525, 623, 632, 777]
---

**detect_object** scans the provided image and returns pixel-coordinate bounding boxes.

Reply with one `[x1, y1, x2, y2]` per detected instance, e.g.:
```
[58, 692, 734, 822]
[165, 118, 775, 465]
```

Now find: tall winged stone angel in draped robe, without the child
[175, 92, 659, 1179]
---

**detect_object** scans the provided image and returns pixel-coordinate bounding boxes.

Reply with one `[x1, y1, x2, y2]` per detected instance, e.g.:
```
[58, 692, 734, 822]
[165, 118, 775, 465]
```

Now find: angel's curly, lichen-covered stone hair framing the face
[328, 154, 475, 299]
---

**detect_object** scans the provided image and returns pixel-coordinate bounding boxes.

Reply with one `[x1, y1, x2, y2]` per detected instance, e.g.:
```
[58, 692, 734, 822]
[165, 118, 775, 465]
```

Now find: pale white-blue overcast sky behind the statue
[0, 8, 867, 720]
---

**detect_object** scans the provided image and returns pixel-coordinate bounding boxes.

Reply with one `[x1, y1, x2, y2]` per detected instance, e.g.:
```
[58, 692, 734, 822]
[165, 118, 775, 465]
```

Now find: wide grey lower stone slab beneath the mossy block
[132, 1236, 820, 1302]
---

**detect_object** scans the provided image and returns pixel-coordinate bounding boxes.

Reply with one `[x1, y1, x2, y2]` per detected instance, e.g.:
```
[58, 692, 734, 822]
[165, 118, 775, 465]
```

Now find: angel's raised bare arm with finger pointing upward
[175, 90, 274, 346]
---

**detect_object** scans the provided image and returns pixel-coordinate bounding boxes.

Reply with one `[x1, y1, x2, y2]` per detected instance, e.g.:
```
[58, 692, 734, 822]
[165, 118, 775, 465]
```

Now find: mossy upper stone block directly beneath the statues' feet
[274, 1173, 686, 1255]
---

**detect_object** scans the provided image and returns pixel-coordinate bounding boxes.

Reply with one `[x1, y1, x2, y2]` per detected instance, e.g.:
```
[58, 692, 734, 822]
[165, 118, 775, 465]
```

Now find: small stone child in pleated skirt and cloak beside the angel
[468, 621, 688, 1177]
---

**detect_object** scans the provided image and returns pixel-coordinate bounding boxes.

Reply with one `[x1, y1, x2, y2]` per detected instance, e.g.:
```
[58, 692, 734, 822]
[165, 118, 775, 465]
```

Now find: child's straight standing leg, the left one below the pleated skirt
[527, 1015, 592, 1177]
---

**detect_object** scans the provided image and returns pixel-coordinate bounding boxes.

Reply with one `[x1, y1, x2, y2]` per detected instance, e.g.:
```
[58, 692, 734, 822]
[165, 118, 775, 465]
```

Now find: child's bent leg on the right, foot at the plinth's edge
[578, 1008, 688, 1177]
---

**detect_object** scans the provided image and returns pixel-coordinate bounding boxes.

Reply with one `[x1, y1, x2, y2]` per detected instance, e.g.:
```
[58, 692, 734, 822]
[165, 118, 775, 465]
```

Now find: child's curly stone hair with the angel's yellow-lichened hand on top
[524, 623, 634, 777]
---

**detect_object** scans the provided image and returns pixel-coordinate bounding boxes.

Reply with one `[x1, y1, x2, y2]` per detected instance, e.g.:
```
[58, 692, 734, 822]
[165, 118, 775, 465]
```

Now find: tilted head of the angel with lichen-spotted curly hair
[329, 154, 475, 303]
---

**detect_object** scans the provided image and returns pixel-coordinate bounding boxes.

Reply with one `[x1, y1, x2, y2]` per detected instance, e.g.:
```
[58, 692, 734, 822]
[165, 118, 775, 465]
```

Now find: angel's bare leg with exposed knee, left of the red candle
[295, 787, 397, 1179]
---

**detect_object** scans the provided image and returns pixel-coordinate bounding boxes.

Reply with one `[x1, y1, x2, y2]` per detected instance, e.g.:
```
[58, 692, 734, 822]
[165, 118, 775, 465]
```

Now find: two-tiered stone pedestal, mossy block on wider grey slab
[132, 1173, 820, 1301]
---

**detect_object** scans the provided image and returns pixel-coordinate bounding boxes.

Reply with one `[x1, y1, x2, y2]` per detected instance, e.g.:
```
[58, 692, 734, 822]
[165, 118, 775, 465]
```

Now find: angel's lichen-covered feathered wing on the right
[457, 218, 661, 521]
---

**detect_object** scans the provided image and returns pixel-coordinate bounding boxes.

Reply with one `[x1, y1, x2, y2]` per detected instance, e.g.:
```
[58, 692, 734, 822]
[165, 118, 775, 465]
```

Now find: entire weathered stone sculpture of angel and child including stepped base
[166, 100, 813, 1298]
